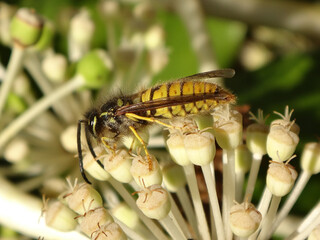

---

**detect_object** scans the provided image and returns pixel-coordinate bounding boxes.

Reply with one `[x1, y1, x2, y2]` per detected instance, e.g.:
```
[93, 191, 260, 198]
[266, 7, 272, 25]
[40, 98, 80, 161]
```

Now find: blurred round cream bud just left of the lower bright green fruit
[42, 54, 68, 83]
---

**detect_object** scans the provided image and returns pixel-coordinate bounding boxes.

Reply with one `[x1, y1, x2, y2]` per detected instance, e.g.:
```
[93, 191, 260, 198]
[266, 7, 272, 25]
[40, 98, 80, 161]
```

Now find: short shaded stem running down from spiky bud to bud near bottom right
[243, 153, 262, 202]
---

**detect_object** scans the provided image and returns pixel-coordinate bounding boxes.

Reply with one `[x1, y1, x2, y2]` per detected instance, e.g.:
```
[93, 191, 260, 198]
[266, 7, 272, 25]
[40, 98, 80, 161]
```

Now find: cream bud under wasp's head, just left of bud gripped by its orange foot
[103, 149, 132, 183]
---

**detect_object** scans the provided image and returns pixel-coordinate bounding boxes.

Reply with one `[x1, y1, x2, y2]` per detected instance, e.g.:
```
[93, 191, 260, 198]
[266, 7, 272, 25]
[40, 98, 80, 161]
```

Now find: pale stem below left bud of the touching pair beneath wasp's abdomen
[183, 165, 210, 240]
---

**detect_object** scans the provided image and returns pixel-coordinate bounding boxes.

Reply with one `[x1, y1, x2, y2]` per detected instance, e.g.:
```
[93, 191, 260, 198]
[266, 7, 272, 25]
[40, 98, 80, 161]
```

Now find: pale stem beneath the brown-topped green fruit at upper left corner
[0, 45, 25, 118]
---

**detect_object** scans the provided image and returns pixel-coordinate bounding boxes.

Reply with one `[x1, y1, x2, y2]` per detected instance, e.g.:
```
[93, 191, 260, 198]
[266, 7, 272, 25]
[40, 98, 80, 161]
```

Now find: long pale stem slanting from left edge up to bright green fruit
[0, 76, 84, 149]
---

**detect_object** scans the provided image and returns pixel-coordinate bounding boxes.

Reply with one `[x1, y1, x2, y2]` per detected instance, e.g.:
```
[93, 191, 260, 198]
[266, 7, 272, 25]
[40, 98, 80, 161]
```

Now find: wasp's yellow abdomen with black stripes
[140, 81, 235, 118]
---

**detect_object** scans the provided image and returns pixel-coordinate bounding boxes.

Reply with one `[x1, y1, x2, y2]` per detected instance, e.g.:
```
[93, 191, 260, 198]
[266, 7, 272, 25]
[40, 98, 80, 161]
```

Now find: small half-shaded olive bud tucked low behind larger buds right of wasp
[235, 144, 252, 173]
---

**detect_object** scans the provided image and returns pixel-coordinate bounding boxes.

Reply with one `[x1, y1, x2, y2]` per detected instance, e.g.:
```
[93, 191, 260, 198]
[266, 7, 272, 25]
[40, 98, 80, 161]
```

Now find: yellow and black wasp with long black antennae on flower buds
[77, 69, 236, 183]
